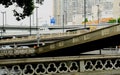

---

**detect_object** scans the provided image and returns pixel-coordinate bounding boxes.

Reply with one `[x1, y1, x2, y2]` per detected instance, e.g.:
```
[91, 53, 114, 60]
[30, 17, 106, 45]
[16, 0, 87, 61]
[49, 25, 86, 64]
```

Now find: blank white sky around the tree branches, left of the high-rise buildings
[0, 0, 53, 26]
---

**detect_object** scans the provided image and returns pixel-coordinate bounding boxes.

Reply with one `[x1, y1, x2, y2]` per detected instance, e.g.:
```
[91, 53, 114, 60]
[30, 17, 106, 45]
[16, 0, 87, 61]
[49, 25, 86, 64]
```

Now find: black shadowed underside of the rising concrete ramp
[38, 35, 120, 57]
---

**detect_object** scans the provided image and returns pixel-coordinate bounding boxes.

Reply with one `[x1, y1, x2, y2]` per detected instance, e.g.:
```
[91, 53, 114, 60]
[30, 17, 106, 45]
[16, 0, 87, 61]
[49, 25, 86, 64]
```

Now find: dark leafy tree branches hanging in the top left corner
[0, 0, 44, 21]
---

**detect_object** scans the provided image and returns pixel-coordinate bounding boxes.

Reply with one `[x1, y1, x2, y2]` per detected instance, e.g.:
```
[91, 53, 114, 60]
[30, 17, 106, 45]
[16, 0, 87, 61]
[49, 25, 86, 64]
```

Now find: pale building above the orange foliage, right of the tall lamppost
[92, 0, 113, 20]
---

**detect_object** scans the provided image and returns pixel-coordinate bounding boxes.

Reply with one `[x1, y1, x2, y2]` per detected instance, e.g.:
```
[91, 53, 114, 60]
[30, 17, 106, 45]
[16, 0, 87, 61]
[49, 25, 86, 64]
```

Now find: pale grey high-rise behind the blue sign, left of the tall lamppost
[53, 0, 83, 25]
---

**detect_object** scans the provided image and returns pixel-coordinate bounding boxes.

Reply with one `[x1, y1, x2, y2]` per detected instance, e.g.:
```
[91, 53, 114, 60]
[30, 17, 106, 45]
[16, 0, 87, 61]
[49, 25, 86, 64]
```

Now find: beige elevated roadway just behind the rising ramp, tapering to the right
[0, 30, 88, 45]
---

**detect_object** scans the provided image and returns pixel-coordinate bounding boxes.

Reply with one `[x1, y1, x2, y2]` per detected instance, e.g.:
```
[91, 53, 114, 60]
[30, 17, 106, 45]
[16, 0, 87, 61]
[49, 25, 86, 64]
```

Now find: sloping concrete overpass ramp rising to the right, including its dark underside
[0, 24, 120, 56]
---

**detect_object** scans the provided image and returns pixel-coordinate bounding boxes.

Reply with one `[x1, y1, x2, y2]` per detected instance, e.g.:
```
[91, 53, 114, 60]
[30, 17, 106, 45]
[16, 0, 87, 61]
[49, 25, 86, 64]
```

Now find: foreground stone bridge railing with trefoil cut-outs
[0, 55, 120, 75]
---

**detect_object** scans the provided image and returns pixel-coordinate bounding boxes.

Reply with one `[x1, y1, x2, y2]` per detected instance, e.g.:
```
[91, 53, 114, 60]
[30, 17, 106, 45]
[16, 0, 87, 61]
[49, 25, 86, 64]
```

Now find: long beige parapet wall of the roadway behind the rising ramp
[0, 31, 86, 44]
